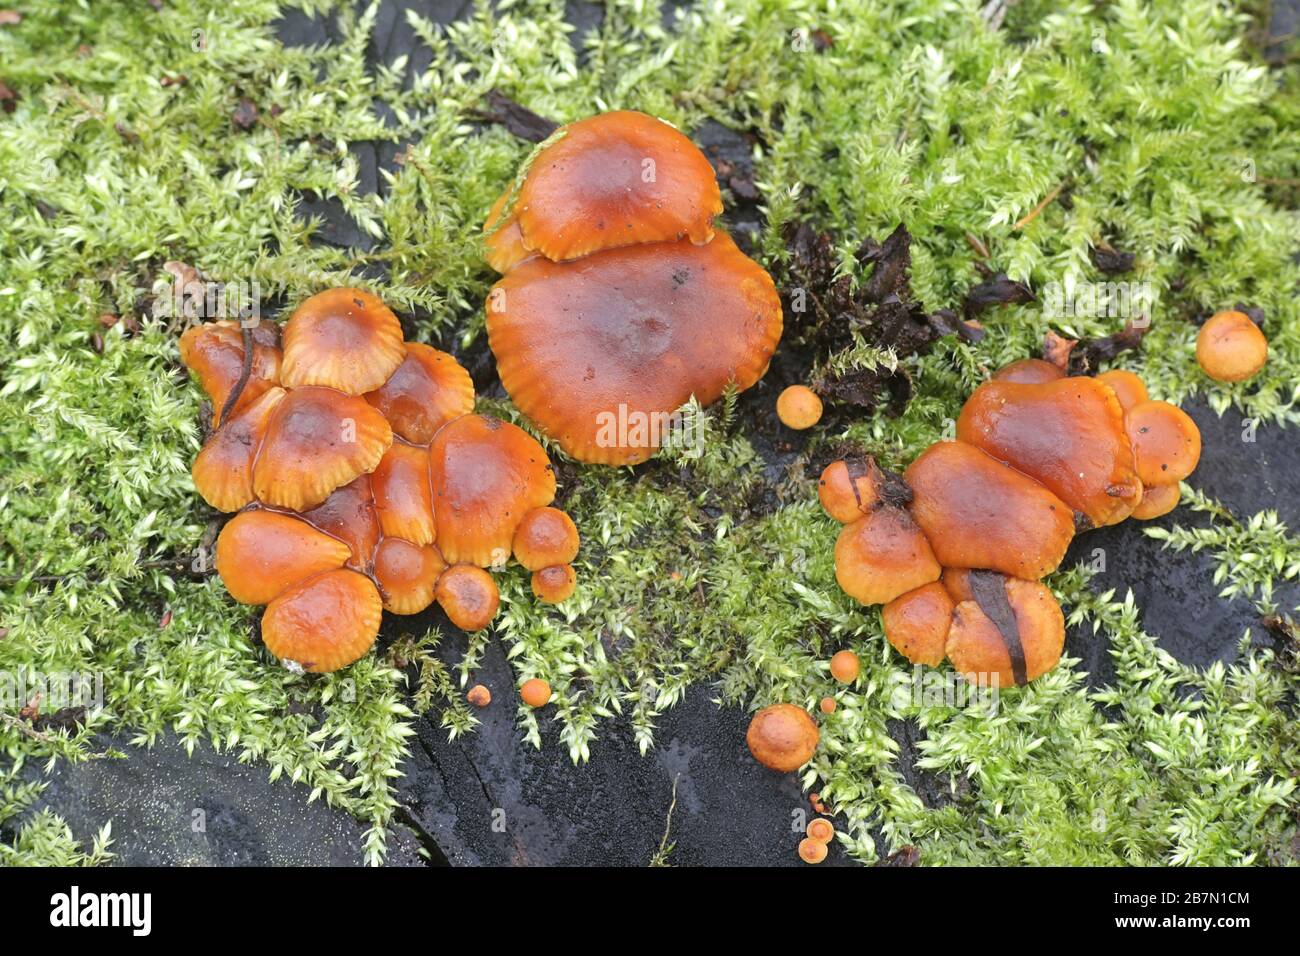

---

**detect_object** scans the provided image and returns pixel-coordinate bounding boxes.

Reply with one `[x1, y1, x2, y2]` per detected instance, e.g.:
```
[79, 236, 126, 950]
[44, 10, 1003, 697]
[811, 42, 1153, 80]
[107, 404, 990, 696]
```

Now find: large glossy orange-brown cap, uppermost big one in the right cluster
[957, 377, 1141, 527]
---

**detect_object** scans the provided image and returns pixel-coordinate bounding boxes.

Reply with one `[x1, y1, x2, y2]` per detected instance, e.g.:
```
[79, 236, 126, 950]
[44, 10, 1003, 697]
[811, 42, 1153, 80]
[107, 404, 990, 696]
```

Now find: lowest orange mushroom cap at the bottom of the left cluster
[261, 568, 384, 674]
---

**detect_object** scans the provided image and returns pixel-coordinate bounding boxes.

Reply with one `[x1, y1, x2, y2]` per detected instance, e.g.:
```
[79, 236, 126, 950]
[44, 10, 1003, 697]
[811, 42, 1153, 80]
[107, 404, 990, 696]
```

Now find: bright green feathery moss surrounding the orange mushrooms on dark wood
[0, 0, 1300, 864]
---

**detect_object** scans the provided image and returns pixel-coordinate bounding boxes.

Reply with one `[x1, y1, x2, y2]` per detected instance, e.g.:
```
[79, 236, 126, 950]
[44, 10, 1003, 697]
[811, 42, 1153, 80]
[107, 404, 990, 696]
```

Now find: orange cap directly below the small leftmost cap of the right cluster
[835, 507, 943, 605]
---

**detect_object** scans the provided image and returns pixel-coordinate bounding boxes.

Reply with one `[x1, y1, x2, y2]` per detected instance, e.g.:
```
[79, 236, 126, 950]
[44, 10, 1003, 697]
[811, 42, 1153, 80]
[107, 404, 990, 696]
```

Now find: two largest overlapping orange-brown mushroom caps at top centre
[485, 112, 783, 464]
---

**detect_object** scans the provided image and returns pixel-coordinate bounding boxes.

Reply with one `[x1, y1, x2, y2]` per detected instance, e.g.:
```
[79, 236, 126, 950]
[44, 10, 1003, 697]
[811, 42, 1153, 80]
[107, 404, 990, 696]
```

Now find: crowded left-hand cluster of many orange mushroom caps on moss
[181, 289, 579, 671]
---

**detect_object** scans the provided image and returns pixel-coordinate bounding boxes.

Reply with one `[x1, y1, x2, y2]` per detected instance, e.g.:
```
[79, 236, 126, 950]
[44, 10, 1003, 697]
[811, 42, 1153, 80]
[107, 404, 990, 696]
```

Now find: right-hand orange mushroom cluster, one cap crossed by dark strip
[818, 359, 1201, 687]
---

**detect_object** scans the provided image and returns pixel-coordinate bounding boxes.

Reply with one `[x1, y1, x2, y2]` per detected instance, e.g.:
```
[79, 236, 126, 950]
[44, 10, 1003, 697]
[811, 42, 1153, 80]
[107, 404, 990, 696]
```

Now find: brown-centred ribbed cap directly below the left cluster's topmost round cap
[252, 385, 393, 511]
